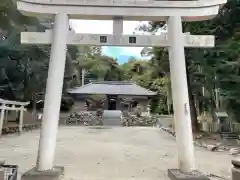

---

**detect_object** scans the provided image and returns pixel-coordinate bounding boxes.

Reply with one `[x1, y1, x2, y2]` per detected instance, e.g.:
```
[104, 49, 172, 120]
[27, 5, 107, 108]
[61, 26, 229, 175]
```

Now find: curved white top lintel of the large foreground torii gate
[17, 0, 227, 21]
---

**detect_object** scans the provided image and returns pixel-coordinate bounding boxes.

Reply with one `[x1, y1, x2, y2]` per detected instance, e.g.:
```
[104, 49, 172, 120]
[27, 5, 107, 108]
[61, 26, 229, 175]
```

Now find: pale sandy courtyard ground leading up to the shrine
[0, 126, 232, 180]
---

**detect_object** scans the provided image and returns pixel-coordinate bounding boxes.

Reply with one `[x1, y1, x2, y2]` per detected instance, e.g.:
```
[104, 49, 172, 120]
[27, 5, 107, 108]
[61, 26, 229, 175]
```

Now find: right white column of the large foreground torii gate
[168, 16, 195, 173]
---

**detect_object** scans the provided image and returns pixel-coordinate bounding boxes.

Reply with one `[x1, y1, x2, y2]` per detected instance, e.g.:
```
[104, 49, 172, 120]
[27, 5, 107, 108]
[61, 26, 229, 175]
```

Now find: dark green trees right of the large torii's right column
[181, 0, 240, 120]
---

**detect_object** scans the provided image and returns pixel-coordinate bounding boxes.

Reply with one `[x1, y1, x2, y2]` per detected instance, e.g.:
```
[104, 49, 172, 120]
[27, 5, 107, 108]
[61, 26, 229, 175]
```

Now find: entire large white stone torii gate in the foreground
[17, 0, 226, 180]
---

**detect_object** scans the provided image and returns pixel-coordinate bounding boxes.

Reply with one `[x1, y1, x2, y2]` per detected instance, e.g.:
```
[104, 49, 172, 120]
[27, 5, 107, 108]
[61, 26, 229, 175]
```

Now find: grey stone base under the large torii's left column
[21, 166, 64, 180]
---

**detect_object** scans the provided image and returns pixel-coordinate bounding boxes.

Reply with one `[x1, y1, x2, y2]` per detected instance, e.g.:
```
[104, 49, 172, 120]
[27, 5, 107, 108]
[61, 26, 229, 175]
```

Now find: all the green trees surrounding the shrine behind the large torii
[0, 0, 240, 120]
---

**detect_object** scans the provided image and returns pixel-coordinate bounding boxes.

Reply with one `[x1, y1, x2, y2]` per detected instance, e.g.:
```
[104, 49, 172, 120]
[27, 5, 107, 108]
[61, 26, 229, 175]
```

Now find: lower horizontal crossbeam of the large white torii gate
[21, 31, 214, 47]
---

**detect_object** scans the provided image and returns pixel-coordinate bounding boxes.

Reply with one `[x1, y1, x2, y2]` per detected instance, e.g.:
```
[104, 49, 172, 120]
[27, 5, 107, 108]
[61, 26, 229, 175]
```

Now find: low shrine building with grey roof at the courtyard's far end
[68, 81, 156, 112]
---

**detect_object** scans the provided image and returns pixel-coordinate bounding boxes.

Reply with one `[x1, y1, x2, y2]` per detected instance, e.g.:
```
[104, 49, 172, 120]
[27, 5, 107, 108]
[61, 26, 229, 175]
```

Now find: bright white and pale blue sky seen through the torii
[70, 20, 142, 64]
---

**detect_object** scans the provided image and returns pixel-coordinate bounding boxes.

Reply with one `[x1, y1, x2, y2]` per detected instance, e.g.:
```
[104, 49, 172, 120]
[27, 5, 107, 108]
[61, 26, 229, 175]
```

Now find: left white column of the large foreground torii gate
[37, 14, 69, 171]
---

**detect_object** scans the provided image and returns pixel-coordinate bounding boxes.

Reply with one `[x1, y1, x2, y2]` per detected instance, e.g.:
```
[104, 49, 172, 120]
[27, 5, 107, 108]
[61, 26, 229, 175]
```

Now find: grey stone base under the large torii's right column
[168, 169, 210, 180]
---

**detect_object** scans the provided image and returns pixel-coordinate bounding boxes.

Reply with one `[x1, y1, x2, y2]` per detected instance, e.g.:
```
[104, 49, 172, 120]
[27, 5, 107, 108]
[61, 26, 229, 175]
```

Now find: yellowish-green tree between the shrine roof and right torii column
[122, 59, 172, 114]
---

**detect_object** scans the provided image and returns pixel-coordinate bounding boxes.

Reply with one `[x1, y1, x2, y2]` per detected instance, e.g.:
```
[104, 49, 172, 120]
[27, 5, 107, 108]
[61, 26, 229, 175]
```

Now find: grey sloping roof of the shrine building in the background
[68, 81, 156, 96]
